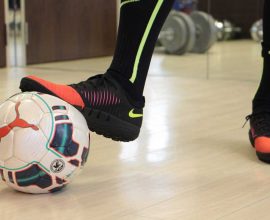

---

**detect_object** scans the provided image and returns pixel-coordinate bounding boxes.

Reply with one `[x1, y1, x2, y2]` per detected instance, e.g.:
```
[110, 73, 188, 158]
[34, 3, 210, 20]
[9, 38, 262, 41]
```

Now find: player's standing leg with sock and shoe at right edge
[248, 0, 270, 163]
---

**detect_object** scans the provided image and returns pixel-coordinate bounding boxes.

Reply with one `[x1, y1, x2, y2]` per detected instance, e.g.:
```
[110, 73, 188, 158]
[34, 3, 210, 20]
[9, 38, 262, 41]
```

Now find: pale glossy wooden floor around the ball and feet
[0, 41, 270, 220]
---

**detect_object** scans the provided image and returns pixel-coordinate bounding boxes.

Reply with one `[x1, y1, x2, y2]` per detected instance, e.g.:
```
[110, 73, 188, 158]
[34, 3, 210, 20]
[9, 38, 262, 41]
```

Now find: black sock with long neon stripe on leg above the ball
[107, 0, 174, 101]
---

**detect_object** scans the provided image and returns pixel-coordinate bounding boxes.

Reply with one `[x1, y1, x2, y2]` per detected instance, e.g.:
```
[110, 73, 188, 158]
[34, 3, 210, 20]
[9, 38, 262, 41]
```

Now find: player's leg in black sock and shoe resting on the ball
[20, 0, 174, 141]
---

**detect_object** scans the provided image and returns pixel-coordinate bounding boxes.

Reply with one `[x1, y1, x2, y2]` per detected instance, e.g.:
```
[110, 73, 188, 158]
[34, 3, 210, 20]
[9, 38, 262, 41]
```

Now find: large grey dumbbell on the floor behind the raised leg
[158, 11, 216, 55]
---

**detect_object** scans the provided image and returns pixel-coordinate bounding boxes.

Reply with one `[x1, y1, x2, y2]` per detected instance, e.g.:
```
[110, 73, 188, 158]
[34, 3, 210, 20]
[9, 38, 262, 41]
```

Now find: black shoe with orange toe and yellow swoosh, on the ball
[20, 74, 144, 142]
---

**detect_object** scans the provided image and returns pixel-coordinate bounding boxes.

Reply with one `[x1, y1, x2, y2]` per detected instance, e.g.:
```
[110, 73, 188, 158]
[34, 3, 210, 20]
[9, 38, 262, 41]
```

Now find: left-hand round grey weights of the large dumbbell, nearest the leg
[159, 11, 196, 55]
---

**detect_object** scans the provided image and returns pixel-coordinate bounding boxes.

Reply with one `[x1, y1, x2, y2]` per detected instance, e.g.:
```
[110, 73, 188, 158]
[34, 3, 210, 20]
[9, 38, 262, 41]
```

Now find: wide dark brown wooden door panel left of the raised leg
[25, 0, 117, 64]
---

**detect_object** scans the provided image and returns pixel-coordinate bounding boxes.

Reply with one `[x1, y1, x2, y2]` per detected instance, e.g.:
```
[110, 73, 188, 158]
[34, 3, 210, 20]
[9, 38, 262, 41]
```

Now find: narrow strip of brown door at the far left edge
[0, 1, 6, 67]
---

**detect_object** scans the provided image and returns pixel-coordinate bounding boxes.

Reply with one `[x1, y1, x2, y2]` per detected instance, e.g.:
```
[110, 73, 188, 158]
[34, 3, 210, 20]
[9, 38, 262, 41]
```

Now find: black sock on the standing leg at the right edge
[253, 0, 270, 113]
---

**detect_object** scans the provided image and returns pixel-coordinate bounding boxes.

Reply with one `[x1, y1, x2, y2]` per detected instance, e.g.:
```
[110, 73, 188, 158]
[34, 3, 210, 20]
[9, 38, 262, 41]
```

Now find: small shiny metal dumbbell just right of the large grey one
[215, 20, 242, 41]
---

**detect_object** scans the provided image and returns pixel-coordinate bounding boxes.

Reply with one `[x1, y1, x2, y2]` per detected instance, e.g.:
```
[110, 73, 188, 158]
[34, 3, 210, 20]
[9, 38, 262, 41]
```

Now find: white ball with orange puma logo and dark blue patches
[0, 93, 90, 194]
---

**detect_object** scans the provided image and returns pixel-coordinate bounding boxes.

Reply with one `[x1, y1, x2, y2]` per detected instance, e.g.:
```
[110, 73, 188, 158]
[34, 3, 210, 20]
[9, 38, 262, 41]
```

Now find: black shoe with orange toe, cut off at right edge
[246, 112, 270, 163]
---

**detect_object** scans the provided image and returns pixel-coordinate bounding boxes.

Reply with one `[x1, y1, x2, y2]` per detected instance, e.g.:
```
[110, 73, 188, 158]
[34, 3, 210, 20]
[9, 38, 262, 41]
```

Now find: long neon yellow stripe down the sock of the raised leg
[129, 0, 164, 83]
